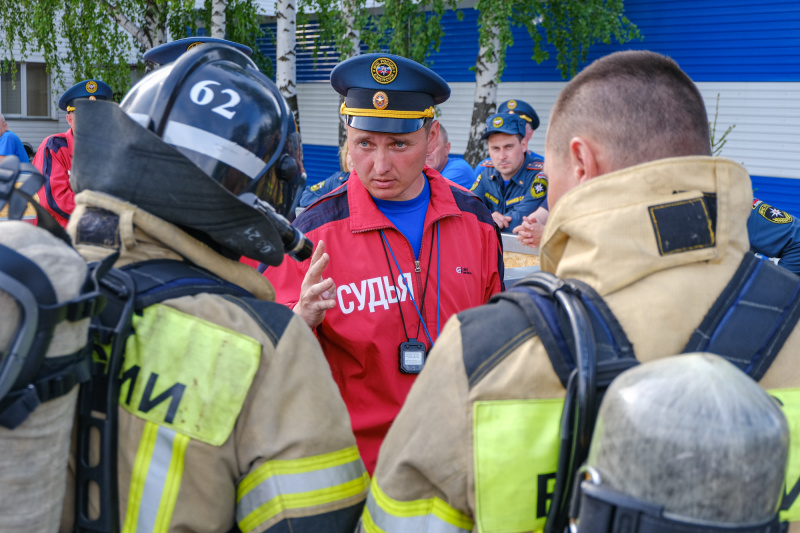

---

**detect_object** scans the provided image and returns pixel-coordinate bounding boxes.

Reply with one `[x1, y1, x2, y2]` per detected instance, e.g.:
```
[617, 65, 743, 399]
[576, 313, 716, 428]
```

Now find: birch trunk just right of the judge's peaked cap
[464, 30, 500, 167]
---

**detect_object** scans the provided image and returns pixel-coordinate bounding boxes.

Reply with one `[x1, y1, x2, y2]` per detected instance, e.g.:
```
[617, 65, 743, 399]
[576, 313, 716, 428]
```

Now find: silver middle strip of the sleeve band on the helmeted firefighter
[236, 459, 364, 523]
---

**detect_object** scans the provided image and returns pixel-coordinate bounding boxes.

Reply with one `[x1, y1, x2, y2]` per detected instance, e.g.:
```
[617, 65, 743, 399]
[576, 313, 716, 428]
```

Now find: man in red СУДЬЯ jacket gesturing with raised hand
[265, 54, 503, 473]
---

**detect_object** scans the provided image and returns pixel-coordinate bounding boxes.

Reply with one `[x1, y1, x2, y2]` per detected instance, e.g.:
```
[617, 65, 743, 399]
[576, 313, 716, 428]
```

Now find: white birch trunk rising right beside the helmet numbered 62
[275, 0, 300, 131]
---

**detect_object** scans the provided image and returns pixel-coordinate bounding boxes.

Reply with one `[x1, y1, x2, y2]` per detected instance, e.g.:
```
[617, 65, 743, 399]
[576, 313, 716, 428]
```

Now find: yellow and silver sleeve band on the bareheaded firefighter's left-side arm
[362, 479, 475, 533]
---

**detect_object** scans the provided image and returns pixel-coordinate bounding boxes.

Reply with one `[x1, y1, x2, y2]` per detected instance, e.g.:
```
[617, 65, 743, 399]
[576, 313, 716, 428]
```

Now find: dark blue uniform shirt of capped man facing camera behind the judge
[470, 154, 547, 233]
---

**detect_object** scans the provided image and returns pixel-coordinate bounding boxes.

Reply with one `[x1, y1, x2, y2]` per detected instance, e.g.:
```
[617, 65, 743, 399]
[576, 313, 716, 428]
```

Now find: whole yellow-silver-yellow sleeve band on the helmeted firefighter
[236, 446, 369, 533]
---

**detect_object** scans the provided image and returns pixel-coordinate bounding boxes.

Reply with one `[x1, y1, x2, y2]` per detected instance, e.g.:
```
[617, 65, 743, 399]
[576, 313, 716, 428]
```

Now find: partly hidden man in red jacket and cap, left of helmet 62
[33, 79, 113, 227]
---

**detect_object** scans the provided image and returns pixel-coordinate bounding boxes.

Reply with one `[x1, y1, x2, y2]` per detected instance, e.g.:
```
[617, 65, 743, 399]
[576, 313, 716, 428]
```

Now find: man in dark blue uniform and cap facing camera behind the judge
[472, 113, 547, 233]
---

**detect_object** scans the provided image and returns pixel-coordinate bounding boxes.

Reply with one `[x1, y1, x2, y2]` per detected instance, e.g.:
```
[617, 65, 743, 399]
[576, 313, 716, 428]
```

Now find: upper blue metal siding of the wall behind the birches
[261, 0, 800, 83]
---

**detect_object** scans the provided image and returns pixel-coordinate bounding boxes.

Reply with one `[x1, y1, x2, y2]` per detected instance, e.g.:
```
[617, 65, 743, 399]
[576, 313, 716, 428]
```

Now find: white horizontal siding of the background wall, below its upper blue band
[298, 82, 800, 178]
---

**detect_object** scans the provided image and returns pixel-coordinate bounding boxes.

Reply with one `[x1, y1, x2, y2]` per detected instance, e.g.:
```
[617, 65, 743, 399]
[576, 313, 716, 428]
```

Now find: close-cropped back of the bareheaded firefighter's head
[547, 51, 711, 170]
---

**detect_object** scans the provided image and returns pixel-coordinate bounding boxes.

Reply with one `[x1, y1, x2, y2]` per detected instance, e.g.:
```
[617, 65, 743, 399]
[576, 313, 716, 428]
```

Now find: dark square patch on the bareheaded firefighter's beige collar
[648, 198, 716, 255]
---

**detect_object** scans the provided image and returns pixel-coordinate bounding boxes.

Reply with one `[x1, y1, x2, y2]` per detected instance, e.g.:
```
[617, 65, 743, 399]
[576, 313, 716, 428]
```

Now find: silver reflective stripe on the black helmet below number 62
[163, 120, 267, 179]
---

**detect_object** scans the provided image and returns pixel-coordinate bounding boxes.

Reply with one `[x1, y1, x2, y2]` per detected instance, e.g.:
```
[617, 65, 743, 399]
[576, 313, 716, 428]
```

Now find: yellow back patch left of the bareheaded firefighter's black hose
[473, 399, 564, 533]
